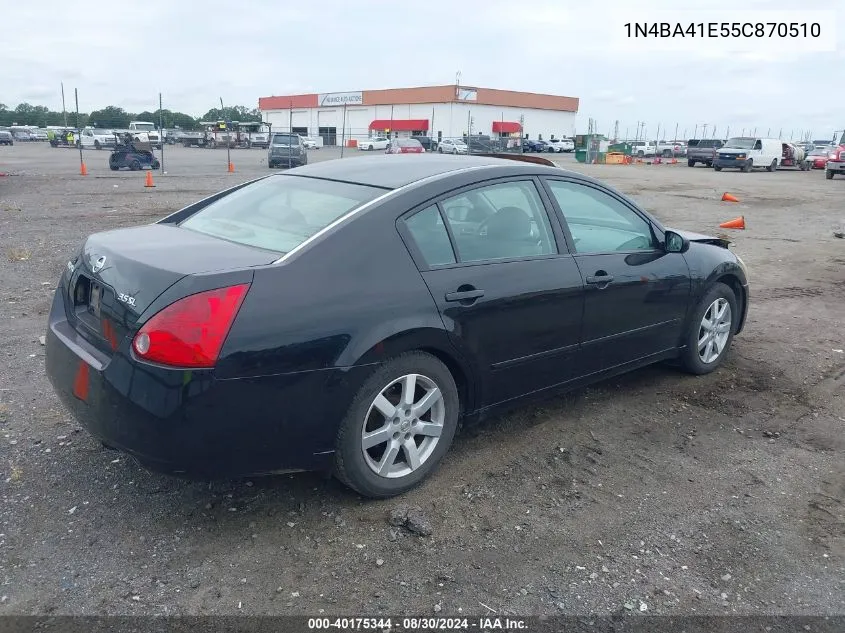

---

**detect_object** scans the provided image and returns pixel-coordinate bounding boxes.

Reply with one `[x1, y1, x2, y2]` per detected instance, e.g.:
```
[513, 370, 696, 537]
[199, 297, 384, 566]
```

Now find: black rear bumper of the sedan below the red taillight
[45, 291, 371, 479]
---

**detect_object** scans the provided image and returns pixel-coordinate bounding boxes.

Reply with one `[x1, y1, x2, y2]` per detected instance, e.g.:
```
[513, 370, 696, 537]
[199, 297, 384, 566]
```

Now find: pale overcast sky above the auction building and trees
[0, 0, 845, 137]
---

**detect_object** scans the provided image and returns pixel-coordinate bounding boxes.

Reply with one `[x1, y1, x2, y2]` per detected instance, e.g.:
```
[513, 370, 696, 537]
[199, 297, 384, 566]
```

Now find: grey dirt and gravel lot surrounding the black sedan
[0, 139, 845, 615]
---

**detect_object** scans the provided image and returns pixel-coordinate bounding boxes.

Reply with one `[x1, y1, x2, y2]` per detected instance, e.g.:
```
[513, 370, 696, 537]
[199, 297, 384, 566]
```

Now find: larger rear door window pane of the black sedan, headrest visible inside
[441, 181, 557, 262]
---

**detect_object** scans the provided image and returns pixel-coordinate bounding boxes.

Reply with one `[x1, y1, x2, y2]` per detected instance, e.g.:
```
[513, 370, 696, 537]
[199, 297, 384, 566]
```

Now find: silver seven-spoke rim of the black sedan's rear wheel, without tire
[361, 374, 446, 479]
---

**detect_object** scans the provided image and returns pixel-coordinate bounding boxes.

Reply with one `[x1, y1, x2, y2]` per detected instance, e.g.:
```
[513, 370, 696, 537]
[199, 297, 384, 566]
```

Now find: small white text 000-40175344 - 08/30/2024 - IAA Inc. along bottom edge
[308, 617, 529, 633]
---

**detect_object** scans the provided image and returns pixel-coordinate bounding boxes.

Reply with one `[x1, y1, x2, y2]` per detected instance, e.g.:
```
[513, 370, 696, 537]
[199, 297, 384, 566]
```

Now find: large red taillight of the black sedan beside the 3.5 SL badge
[132, 284, 249, 367]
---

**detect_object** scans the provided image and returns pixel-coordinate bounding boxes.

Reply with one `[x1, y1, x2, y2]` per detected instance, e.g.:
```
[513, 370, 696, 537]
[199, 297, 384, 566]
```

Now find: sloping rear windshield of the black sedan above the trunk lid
[180, 175, 385, 254]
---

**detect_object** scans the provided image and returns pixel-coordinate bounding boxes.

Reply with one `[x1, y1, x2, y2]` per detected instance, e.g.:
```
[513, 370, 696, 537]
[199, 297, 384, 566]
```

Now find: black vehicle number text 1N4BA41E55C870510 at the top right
[623, 22, 822, 39]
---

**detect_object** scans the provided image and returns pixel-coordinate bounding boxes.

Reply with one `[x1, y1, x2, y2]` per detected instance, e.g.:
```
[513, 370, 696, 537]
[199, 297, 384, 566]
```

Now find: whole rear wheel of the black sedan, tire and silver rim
[335, 352, 460, 498]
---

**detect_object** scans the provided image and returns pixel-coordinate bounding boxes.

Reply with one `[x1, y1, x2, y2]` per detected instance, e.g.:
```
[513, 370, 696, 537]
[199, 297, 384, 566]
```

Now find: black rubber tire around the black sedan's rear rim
[335, 352, 460, 499]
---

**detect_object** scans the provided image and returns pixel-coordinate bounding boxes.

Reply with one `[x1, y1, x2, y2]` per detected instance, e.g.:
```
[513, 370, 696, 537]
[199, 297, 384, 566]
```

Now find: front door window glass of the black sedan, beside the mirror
[549, 180, 655, 253]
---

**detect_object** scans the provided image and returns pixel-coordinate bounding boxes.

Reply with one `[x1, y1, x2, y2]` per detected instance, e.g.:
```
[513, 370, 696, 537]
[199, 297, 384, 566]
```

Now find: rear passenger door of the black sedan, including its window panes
[400, 177, 584, 408]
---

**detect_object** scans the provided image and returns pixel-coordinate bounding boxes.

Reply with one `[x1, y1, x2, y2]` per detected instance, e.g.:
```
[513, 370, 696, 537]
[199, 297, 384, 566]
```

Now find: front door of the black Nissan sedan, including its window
[544, 178, 691, 375]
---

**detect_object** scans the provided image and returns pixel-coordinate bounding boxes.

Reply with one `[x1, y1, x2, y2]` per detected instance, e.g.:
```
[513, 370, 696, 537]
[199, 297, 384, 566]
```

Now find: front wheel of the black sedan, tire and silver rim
[681, 282, 739, 375]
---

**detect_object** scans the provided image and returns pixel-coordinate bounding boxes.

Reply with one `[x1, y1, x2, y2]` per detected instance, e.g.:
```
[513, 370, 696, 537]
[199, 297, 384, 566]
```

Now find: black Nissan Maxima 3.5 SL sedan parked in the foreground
[46, 154, 748, 497]
